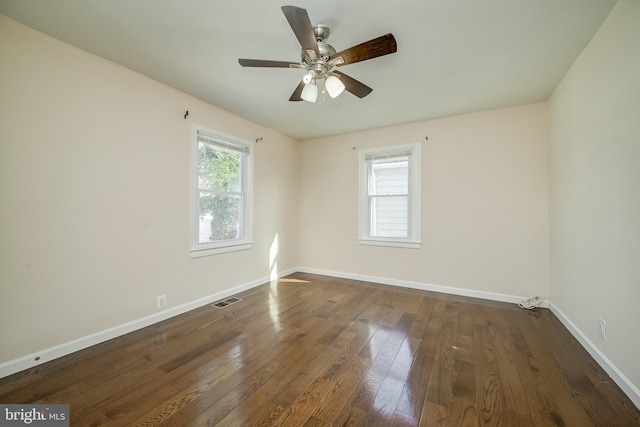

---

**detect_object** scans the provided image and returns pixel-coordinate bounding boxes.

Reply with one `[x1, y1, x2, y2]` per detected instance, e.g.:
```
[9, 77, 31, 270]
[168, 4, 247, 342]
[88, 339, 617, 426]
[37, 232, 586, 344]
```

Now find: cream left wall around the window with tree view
[0, 15, 297, 364]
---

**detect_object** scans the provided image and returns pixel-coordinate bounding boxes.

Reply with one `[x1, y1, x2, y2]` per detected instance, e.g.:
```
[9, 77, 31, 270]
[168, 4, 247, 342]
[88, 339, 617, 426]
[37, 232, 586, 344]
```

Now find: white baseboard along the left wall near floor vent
[0, 268, 297, 378]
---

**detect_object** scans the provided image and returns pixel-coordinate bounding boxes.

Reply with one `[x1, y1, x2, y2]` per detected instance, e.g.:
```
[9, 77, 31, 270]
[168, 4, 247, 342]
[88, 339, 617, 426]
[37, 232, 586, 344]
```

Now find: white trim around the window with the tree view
[190, 124, 253, 258]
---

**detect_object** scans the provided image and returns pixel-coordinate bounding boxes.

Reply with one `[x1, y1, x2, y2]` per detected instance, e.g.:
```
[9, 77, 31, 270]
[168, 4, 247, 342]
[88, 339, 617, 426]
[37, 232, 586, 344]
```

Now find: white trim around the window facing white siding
[358, 144, 422, 249]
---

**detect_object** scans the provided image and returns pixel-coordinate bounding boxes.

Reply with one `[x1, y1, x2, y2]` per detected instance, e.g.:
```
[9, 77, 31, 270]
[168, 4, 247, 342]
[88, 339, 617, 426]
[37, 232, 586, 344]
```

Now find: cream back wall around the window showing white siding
[298, 103, 549, 298]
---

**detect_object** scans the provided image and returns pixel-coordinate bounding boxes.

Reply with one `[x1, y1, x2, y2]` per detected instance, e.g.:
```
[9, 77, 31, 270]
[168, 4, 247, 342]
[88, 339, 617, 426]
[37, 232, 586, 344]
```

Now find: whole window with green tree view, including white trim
[191, 127, 252, 257]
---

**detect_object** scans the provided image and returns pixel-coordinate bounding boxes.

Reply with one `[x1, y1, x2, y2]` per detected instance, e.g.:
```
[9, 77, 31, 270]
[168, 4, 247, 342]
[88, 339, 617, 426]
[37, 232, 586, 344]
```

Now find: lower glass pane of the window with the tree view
[198, 191, 242, 243]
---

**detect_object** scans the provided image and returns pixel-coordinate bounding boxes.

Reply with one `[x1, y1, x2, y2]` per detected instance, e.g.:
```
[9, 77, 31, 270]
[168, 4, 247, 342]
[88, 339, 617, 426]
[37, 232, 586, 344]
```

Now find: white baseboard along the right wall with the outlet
[549, 303, 640, 409]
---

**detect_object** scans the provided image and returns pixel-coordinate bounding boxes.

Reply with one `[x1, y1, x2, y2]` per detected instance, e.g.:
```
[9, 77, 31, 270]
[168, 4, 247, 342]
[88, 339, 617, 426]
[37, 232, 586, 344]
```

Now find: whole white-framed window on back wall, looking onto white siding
[359, 144, 421, 248]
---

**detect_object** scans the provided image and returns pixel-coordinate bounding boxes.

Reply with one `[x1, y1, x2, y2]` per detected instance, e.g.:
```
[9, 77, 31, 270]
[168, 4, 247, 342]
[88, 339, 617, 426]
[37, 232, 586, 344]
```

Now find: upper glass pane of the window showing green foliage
[198, 142, 243, 192]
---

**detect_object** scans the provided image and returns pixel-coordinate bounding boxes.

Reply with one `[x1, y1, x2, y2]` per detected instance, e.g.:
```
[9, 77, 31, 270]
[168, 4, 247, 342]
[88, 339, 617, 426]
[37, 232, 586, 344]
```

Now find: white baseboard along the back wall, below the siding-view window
[298, 267, 549, 308]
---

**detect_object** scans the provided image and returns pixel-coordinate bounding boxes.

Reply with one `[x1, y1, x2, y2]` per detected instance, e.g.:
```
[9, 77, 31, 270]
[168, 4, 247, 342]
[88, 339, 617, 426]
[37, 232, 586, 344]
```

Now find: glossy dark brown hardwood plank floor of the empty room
[0, 273, 640, 427]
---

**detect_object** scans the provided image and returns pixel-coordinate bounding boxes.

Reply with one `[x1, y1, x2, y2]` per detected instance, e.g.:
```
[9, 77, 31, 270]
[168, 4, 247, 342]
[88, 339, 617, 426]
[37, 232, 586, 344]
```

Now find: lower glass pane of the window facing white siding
[370, 196, 409, 238]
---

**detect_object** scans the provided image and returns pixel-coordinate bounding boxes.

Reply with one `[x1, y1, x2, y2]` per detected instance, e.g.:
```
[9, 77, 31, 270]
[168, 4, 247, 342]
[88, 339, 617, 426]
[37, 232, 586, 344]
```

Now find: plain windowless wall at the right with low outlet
[550, 0, 640, 394]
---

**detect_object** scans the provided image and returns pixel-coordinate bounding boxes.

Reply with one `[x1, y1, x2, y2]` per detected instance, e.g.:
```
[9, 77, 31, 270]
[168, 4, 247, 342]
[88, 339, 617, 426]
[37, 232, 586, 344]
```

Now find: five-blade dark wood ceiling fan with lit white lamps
[238, 6, 398, 102]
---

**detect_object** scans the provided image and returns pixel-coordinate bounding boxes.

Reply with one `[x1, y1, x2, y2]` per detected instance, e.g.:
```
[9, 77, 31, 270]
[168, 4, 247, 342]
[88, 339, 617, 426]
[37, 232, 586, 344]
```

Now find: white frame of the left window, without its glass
[190, 125, 253, 258]
